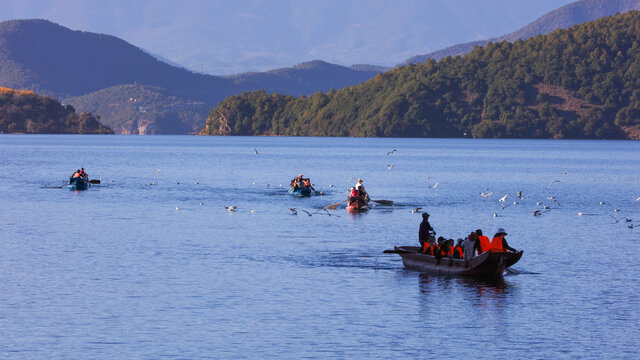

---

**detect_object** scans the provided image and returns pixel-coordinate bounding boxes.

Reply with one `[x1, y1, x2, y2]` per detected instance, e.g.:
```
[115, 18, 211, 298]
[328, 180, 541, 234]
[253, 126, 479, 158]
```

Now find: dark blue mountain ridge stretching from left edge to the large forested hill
[0, 20, 380, 134]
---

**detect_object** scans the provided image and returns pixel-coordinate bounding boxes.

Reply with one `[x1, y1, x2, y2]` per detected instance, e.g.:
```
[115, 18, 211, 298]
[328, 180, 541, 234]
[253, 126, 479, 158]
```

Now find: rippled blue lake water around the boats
[0, 135, 640, 359]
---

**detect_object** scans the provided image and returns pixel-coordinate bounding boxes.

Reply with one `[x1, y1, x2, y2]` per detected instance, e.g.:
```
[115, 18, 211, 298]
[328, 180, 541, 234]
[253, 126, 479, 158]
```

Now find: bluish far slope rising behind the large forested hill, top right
[401, 0, 640, 65]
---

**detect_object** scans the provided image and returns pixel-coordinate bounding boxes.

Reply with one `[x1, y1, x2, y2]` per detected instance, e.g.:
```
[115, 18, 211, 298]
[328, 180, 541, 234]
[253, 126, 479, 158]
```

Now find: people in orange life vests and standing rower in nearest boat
[418, 213, 517, 260]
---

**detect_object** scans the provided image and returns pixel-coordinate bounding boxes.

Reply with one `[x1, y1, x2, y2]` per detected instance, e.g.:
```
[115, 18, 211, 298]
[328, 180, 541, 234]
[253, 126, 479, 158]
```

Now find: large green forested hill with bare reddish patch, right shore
[201, 11, 640, 139]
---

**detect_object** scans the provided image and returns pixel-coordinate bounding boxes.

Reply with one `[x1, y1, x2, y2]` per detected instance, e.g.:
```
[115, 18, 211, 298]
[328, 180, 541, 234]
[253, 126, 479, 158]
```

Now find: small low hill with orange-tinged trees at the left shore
[0, 88, 113, 134]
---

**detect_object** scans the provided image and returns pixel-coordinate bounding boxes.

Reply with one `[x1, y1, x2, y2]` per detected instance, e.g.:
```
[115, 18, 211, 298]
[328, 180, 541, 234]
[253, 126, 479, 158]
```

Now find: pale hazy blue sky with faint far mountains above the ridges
[0, 0, 573, 75]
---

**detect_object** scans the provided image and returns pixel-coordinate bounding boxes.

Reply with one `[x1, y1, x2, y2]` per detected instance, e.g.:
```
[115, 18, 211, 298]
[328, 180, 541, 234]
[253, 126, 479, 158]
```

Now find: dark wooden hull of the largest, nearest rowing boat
[385, 246, 522, 276]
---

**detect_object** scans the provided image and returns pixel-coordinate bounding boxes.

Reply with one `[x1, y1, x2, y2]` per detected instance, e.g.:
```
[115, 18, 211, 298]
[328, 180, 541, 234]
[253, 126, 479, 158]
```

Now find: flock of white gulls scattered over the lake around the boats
[162, 148, 640, 229]
